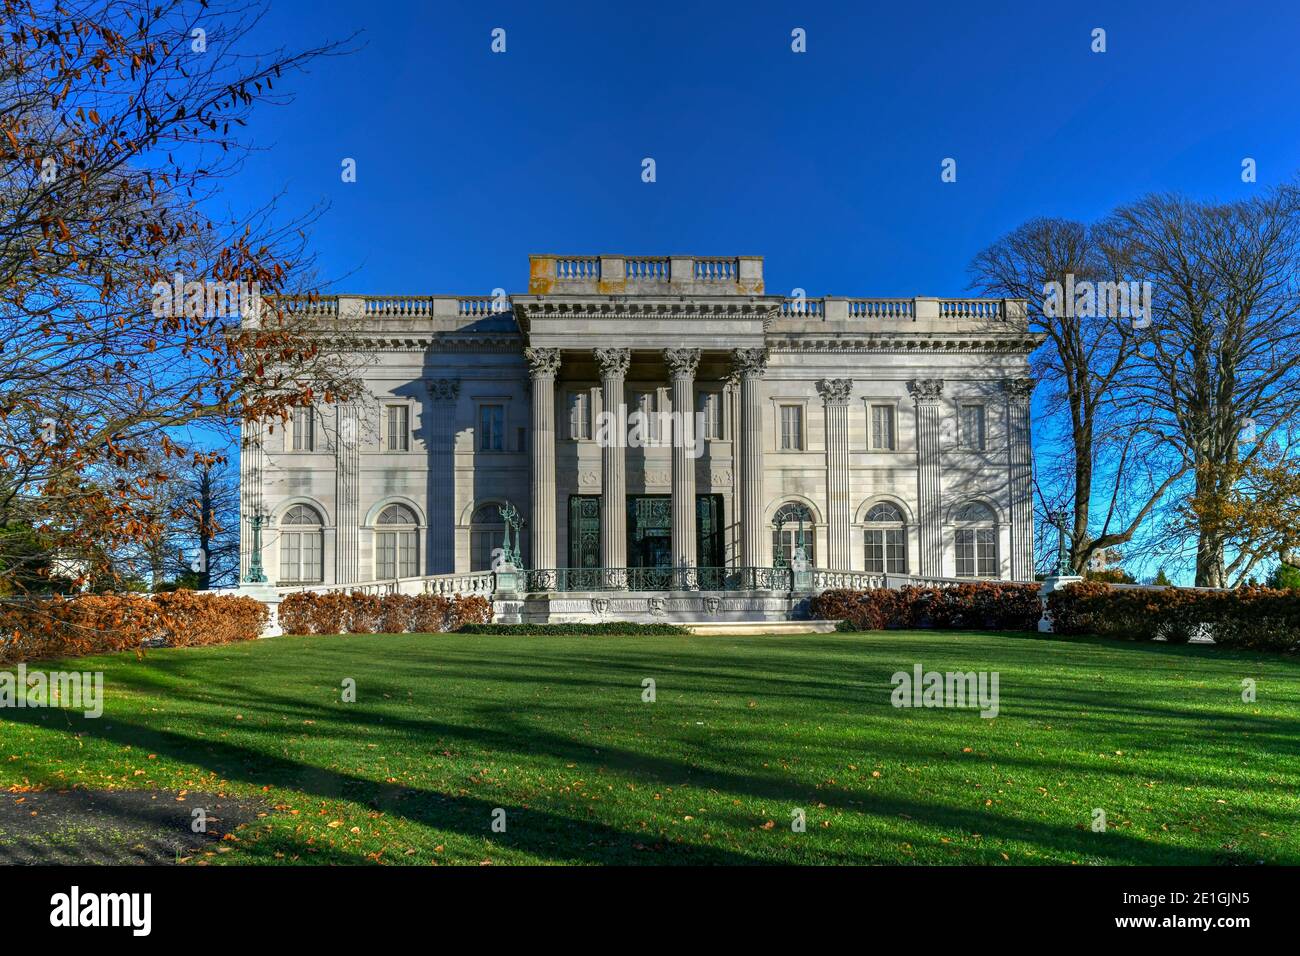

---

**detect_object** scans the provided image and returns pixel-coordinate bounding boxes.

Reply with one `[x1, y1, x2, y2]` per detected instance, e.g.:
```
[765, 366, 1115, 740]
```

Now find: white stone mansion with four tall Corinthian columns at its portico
[241, 255, 1040, 616]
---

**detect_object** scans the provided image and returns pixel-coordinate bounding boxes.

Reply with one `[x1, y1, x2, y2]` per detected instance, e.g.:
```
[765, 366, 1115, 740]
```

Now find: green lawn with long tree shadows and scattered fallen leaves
[0, 632, 1300, 865]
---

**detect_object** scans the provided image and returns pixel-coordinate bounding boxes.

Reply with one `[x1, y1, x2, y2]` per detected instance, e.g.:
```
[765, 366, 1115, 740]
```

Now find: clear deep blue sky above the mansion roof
[226, 0, 1300, 295]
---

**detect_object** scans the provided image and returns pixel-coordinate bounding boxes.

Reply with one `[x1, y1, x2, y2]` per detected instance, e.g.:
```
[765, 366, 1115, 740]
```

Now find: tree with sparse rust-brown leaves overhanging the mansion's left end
[0, 0, 356, 591]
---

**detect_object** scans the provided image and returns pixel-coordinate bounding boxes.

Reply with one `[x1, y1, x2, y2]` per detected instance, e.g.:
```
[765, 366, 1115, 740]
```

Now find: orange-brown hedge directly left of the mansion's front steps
[280, 591, 491, 635]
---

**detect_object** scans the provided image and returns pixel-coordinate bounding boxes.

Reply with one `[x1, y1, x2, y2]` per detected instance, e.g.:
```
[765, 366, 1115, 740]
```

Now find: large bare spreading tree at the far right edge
[1106, 185, 1300, 587]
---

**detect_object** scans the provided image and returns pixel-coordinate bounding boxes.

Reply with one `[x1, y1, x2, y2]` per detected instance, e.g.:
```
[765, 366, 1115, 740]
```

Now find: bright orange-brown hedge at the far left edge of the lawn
[0, 591, 267, 665]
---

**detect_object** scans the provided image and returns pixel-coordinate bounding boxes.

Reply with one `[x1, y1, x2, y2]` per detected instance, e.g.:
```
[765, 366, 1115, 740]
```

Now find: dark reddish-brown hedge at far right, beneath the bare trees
[1048, 583, 1300, 653]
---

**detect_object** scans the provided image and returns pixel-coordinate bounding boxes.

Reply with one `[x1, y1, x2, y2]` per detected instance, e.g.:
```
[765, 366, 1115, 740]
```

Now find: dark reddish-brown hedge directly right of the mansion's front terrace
[809, 581, 1043, 631]
